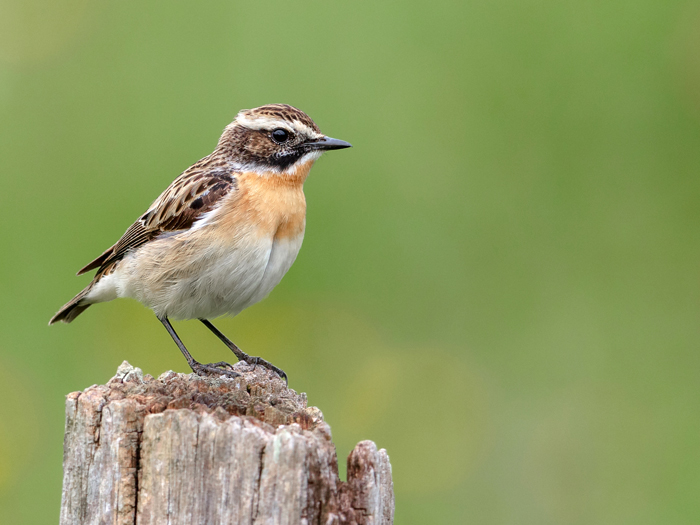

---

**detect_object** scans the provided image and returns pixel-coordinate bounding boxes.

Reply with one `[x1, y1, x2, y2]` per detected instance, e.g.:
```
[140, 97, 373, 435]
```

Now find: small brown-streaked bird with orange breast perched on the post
[49, 104, 351, 382]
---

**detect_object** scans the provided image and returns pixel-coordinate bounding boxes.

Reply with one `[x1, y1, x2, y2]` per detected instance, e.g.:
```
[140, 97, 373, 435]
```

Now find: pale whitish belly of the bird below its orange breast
[95, 232, 304, 319]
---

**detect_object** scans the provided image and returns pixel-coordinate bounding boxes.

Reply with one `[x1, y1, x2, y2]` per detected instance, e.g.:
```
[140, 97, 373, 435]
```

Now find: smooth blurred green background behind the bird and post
[0, 0, 700, 525]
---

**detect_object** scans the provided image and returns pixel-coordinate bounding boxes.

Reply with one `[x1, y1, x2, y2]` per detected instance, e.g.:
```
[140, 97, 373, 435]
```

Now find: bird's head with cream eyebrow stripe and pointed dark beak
[219, 104, 351, 174]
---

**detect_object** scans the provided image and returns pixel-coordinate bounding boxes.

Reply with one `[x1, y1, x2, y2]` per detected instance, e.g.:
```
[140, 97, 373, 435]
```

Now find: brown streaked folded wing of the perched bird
[78, 163, 236, 275]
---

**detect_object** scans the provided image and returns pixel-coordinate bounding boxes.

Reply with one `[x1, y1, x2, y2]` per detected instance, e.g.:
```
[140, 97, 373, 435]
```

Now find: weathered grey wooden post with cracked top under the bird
[61, 361, 394, 525]
